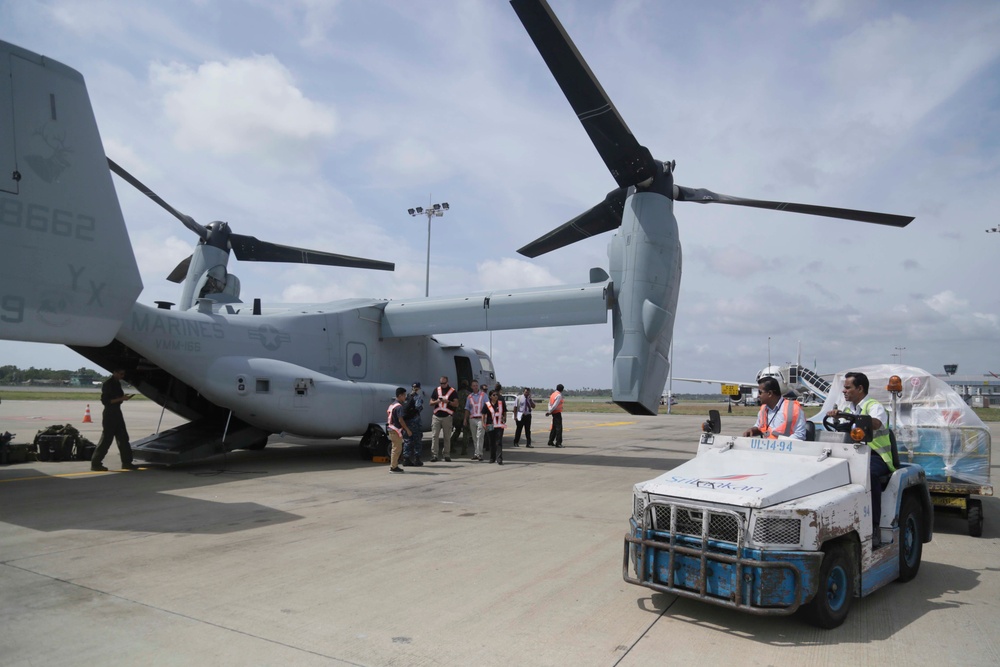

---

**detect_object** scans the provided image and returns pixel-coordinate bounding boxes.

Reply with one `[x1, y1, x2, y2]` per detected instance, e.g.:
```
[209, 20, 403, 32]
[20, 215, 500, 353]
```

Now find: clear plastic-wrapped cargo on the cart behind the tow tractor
[817, 364, 993, 495]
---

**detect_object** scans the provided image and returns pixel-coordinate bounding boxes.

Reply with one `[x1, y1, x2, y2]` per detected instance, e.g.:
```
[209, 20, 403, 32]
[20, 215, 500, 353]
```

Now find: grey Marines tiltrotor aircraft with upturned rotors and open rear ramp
[0, 0, 912, 463]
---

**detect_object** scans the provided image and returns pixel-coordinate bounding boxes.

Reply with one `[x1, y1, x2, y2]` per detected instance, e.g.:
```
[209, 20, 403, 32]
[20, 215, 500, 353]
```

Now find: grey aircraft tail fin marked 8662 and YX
[0, 41, 142, 346]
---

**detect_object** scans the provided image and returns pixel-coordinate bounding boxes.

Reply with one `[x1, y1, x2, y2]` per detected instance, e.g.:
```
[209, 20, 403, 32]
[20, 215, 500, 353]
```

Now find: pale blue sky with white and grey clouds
[0, 0, 1000, 392]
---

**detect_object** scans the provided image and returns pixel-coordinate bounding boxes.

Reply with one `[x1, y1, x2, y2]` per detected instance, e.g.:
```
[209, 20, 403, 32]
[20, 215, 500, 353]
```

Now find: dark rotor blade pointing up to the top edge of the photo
[510, 0, 656, 186]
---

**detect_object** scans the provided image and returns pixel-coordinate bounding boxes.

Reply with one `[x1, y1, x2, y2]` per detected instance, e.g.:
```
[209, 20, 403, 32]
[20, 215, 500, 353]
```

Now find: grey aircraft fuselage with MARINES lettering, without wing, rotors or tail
[106, 299, 493, 437]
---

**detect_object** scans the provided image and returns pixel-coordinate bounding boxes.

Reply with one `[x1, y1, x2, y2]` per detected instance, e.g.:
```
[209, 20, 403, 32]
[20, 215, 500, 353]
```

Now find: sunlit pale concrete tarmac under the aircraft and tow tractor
[0, 401, 1000, 667]
